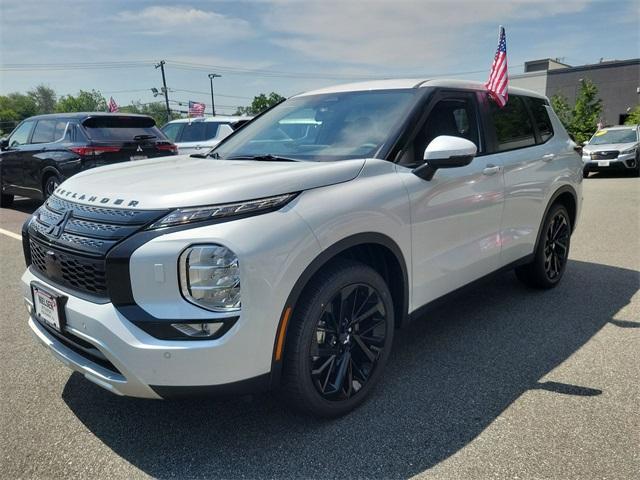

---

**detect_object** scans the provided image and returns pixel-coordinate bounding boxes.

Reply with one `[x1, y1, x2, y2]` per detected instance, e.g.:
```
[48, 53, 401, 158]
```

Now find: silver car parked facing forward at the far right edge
[582, 125, 640, 178]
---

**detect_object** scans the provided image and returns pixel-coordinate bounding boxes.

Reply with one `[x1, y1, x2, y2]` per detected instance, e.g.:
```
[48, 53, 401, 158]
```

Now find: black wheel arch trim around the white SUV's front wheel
[271, 232, 409, 387]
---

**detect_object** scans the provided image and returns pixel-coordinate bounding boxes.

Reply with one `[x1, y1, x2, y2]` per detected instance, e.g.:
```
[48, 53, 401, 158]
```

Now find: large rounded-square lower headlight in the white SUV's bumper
[178, 248, 240, 312]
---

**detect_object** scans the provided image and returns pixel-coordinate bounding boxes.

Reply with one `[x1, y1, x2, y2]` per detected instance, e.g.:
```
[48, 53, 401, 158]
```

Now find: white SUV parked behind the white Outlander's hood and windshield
[162, 115, 251, 155]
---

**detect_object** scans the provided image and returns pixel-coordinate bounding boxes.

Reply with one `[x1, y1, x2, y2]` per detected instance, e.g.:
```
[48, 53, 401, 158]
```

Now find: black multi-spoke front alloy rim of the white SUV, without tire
[310, 283, 387, 401]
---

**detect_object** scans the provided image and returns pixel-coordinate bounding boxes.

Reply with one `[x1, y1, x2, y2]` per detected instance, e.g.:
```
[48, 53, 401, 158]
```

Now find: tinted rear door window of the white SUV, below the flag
[489, 95, 536, 152]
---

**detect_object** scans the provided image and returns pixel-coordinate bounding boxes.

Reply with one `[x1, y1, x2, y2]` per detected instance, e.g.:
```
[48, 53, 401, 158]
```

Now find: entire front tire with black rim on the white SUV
[282, 260, 394, 418]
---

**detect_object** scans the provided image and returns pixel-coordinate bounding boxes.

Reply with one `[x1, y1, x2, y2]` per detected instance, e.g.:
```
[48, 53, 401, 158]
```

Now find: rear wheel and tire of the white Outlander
[516, 204, 571, 289]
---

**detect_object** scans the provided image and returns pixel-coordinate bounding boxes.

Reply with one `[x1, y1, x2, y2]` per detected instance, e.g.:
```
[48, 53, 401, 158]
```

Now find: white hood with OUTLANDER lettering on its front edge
[55, 155, 365, 210]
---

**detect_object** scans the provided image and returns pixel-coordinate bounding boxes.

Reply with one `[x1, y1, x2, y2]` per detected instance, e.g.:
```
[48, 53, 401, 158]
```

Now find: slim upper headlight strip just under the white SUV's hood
[149, 193, 297, 228]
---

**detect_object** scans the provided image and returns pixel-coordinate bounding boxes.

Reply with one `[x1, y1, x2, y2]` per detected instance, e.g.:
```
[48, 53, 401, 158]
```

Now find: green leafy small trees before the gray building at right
[551, 79, 602, 144]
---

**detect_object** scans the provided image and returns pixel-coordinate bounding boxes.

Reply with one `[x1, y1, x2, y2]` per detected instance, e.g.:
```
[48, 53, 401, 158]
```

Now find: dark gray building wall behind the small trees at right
[544, 59, 640, 125]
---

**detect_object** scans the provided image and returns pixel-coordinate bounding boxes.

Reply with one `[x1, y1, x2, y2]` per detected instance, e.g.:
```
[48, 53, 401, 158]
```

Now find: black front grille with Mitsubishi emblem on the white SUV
[27, 196, 166, 298]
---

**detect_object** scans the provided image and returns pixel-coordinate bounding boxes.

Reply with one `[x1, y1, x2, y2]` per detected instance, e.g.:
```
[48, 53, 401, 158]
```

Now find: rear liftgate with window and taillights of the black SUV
[82, 115, 176, 167]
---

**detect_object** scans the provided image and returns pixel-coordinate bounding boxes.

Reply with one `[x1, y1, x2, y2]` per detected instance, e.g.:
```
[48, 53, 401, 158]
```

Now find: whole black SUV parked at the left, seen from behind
[0, 113, 177, 207]
